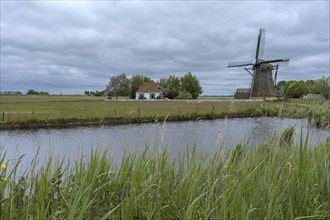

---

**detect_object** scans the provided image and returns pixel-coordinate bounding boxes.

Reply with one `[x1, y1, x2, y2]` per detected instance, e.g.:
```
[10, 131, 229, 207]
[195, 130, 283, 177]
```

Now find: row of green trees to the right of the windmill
[276, 76, 330, 99]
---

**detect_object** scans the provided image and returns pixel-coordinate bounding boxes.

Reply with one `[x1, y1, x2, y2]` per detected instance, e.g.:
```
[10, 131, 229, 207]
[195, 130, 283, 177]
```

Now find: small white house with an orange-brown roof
[135, 82, 162, 100]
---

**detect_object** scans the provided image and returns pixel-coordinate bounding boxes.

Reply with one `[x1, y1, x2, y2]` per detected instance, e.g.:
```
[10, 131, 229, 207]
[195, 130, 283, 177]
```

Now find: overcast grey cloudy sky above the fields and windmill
[0, 0, 330, 95]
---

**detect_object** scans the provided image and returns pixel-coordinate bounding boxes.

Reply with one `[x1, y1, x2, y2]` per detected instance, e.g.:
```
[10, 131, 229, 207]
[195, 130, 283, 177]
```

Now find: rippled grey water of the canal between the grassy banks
[0, 117, 329, 166]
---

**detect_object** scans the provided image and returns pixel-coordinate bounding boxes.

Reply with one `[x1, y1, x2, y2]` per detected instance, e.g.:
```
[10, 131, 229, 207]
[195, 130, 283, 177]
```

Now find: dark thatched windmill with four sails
[227, 28, 290, 100]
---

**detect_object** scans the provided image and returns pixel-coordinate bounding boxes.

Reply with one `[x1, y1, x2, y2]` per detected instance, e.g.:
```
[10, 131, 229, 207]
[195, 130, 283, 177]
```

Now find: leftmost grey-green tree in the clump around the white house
[106, 73, 130, 99]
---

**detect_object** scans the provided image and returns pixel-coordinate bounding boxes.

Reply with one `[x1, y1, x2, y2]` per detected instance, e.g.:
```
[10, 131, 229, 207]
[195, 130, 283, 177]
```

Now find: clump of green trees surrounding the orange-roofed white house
[106, 72, 203, 99]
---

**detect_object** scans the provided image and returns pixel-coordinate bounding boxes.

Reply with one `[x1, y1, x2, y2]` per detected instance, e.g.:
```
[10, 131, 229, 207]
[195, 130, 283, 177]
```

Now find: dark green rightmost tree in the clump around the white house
[181, 72, 203, 99]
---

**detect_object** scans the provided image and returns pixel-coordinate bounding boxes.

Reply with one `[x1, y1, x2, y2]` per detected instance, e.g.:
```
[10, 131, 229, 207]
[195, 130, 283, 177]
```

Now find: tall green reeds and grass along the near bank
[0, 131, 330, 219]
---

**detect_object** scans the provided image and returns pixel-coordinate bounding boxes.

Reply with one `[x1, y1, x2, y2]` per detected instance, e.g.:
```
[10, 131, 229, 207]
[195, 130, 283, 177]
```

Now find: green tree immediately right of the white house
[159, 76, 181, 99]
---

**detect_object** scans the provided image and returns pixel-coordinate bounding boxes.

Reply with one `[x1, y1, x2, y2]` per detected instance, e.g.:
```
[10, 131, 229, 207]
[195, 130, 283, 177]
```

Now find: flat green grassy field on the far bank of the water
[0, 95, 330, 127]
